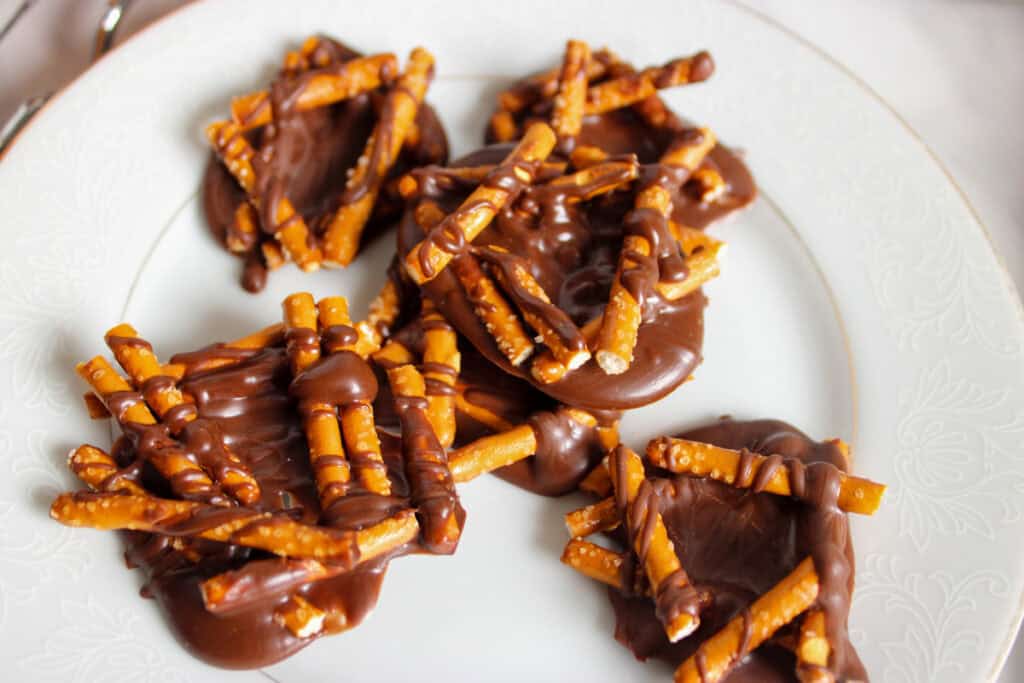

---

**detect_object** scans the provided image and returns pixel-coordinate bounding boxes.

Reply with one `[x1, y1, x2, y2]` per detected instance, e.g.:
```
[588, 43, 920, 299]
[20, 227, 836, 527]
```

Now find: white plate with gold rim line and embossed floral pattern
[0, 0, 1024, 683]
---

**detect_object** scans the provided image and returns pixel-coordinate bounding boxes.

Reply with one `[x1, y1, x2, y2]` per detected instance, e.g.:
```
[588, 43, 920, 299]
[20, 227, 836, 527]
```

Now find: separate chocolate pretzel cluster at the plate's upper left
[203, 36, 447, 292]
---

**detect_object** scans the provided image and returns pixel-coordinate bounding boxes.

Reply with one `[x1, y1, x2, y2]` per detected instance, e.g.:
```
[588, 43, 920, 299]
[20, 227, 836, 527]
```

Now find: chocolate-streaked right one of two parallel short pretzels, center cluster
[473, 245, 590, 371]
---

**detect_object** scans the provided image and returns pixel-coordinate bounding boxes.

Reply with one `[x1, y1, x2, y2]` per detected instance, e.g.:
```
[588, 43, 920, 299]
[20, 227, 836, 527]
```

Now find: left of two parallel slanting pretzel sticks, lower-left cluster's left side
[75, 355, 222, 503]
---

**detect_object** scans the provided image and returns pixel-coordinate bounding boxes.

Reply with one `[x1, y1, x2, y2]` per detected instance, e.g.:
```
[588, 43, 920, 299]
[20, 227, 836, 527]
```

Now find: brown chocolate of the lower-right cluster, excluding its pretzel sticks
[609, 420, 867, 683]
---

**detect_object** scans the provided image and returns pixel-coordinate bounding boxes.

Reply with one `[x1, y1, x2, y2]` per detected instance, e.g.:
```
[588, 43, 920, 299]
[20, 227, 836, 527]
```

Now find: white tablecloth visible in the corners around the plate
[0, 0, 1024, 683]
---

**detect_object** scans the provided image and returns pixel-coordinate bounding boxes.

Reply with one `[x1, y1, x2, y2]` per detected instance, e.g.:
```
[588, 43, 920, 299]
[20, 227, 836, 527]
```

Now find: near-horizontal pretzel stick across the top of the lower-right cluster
[647, 436, 886, 515]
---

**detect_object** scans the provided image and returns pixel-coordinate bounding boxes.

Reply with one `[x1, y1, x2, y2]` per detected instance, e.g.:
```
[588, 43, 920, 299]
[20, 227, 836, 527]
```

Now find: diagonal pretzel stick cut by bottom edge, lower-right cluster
[675, 557, 818, 683]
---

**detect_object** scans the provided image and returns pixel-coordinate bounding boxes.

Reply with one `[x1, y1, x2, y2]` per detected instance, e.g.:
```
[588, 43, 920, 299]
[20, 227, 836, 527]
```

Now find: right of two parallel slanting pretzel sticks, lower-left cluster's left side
[104, 324, 260, 505]
